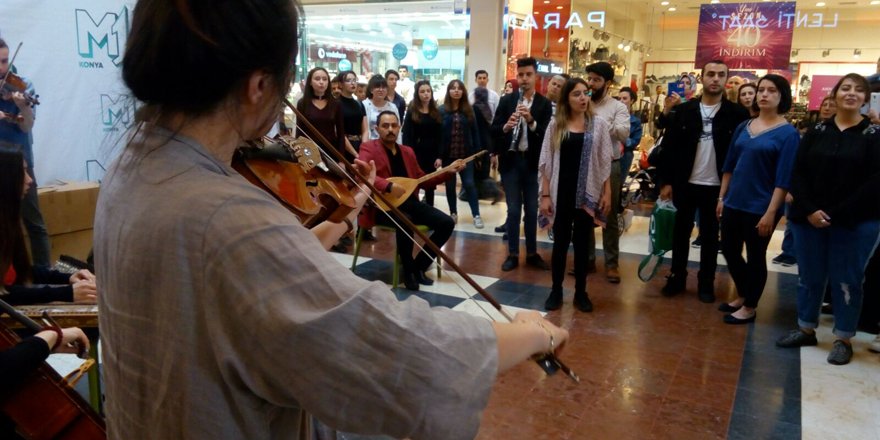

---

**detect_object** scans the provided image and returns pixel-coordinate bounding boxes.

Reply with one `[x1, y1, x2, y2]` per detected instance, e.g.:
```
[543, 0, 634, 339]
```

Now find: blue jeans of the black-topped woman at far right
[791, 220, 880, 339]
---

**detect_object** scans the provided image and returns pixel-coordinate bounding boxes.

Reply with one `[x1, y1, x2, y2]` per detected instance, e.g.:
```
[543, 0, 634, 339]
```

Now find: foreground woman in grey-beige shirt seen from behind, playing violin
[95, 0, 568, 439]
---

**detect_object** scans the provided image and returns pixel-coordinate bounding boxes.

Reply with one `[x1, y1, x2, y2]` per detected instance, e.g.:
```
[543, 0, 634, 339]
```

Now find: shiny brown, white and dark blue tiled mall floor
[335, 191, 880, 439]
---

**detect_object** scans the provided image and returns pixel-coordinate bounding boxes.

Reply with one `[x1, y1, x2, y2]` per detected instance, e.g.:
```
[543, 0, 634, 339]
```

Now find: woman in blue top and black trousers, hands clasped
[717, 74, 800, 324]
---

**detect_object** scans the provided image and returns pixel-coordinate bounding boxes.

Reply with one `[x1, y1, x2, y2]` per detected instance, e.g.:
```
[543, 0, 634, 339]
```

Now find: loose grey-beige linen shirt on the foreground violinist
[95, 127, 498, 440]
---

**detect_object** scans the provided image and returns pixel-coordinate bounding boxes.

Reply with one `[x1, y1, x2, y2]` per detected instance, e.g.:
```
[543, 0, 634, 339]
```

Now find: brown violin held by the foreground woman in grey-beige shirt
[232, 135, 357, 228]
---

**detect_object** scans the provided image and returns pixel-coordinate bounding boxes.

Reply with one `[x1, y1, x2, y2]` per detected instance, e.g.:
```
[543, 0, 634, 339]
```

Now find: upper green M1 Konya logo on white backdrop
[75, 6, 130, 69]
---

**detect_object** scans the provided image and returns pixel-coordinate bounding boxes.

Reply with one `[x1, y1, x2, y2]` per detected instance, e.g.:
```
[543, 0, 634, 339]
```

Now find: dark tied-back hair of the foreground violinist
[122, 0, 300, 116]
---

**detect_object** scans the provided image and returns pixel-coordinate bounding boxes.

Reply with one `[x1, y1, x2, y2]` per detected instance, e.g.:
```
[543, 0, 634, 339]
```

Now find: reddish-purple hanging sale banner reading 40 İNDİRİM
[694, 2, 797, 69]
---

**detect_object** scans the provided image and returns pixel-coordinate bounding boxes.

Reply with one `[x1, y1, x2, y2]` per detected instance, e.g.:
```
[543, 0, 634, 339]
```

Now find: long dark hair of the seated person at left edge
[0, 150, 31, 284]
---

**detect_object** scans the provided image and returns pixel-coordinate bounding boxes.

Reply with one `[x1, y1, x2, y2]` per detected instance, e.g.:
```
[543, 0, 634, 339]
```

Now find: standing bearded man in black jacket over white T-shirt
[657, 60, 749, 303]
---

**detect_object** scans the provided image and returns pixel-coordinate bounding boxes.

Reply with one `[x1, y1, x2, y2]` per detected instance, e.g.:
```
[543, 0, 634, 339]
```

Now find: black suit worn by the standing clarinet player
[492, 93, 553, 256]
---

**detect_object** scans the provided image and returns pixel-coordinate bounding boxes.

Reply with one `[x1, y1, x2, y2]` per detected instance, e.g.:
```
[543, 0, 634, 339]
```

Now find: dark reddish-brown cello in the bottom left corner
[0, 300, 107, 440]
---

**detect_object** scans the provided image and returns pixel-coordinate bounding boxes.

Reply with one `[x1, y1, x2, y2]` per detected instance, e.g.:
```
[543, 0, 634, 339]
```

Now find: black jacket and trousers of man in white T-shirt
[657, 97, 749, 292]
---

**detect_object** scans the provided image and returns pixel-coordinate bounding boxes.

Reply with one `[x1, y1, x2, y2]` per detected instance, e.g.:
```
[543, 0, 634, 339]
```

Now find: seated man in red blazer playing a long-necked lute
[358, 111, 464, 290]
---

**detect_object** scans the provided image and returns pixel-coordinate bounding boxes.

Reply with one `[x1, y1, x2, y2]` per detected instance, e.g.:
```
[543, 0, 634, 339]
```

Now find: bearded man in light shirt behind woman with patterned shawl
[587, 61, 629, 284]
